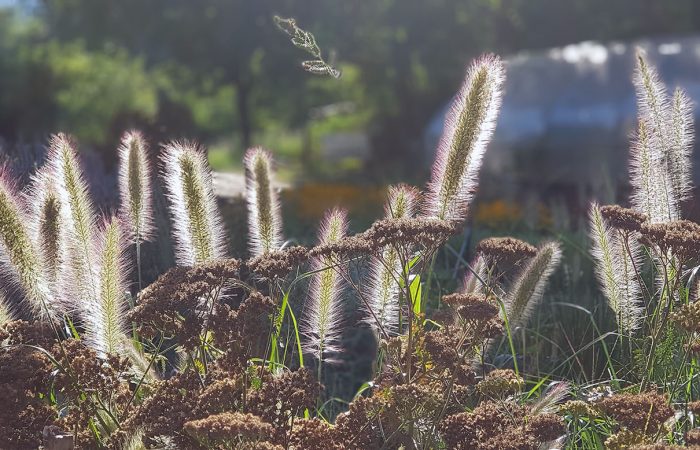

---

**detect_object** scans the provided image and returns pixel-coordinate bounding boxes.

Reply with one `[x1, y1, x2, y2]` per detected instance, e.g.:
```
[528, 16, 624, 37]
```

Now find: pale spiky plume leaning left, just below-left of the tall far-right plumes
[589, 203, 643, 333]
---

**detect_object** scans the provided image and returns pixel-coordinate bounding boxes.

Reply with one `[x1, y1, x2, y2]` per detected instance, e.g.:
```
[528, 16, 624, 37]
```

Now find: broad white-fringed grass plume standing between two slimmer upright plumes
[161, 141, 226, 266]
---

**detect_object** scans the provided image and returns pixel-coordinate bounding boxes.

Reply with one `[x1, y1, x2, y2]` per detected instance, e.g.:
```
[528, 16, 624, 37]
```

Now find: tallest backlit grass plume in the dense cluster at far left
[47, 134, 100, 310]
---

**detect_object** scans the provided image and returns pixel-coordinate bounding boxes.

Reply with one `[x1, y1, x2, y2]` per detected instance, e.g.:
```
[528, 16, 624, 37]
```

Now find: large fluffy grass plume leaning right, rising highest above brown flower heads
[425, 55, 504, 220]
